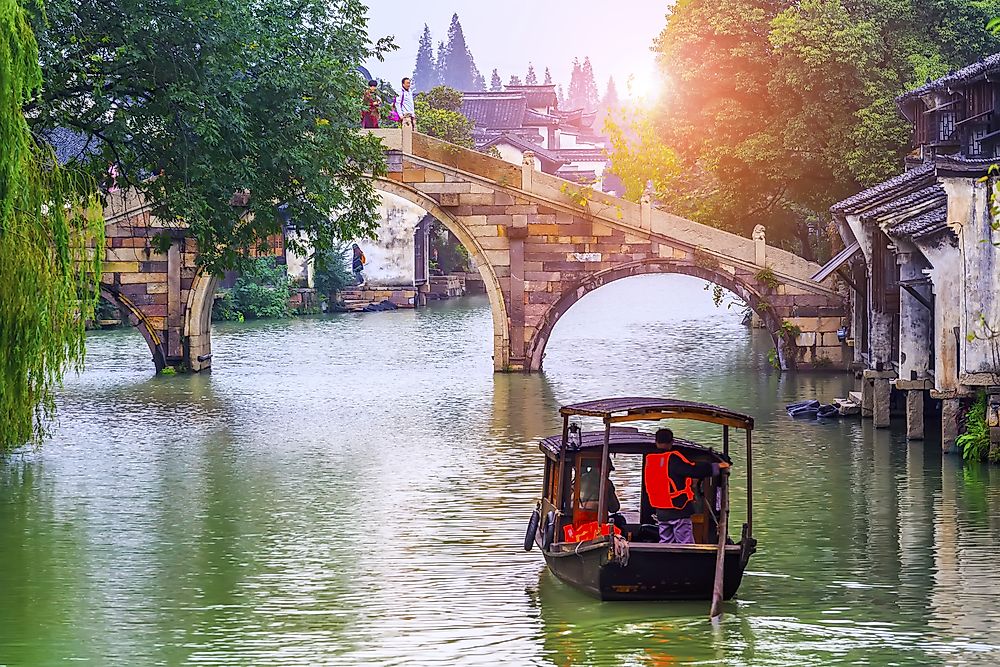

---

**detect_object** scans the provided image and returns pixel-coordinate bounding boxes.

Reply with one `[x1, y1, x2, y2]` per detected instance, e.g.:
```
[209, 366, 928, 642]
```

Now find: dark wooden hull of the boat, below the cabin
[544, 542, 749, 600]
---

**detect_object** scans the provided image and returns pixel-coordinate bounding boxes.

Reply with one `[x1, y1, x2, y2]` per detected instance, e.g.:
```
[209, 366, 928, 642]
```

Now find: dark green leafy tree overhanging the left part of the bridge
[27, 0, 392, 270]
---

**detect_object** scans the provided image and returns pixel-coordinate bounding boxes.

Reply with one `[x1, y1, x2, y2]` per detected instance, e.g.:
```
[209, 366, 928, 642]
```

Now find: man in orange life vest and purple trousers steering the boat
[644, 428, 729, 544]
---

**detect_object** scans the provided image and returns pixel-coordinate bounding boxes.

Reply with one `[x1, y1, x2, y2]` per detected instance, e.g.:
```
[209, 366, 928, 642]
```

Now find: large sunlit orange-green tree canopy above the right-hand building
[655, 0, 1000, 256]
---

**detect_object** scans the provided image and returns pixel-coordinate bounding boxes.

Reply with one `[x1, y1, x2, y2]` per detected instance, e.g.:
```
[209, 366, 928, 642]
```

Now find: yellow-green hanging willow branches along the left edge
[0, 0, 104, 455]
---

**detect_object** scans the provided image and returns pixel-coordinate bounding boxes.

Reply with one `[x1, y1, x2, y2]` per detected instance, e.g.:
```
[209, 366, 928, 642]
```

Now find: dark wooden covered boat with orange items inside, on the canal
[524, 398, 757, 613]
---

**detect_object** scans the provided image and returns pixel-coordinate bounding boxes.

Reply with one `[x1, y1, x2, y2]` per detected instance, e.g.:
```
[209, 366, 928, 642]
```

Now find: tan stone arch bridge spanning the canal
[102, 128, 851, 371]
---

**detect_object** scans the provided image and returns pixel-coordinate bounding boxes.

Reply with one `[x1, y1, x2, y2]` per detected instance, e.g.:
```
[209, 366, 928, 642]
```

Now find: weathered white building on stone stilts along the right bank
[815, 54, 1000, 450]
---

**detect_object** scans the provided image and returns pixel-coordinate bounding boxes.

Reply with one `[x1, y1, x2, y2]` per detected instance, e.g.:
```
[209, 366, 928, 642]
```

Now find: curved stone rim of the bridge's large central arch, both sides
[180, 178, 510, 371]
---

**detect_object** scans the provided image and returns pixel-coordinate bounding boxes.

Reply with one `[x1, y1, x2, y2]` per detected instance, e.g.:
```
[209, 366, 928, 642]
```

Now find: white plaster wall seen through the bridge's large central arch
[356, 193, 426, 287]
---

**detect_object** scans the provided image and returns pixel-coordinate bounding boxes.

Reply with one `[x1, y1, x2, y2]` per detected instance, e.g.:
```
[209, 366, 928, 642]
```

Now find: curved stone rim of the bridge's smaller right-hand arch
[526, 259, 784, 371]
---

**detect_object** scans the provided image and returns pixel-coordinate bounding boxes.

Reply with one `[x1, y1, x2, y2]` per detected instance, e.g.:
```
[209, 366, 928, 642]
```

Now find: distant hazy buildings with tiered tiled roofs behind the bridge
[462, 84, 607, 188]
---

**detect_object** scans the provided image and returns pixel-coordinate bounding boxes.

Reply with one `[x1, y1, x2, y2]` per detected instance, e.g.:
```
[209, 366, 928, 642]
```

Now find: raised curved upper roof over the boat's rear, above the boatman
[559, 398, 753, 430]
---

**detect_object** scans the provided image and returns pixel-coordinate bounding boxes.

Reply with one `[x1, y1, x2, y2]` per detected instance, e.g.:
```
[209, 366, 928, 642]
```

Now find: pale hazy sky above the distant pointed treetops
[367, 0, 673, 95]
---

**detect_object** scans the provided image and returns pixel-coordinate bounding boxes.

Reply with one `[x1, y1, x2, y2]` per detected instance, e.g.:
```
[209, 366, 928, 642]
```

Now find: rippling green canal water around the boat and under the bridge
[0, 276, 1000, 665]
